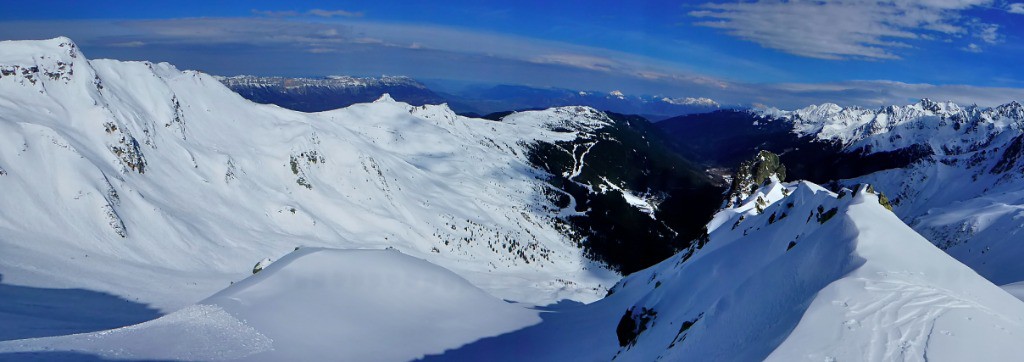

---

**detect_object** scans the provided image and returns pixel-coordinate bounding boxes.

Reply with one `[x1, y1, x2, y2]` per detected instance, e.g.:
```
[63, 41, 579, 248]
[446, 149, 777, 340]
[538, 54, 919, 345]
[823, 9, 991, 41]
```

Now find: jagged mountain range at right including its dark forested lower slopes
[659, 99, 1024, 284]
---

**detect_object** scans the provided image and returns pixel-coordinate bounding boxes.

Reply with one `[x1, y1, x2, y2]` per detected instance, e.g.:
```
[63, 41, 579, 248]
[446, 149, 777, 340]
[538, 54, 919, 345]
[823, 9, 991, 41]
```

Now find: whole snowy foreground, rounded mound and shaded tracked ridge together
[8, 175, 1024, 361]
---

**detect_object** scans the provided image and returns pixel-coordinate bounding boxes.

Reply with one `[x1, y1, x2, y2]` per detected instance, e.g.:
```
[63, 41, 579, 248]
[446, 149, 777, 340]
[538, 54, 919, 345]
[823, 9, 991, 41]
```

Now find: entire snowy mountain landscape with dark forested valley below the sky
[0, 38, 1024, 361]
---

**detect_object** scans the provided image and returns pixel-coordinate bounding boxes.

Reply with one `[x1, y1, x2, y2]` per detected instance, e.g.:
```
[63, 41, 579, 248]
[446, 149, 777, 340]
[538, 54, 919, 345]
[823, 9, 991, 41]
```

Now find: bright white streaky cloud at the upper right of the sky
[690, 0, 998, 59]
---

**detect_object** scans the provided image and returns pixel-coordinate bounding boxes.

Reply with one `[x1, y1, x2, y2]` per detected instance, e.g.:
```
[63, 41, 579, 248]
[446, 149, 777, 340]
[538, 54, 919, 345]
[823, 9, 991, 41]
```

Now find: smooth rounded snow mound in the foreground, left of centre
[0, 247, 541, 361]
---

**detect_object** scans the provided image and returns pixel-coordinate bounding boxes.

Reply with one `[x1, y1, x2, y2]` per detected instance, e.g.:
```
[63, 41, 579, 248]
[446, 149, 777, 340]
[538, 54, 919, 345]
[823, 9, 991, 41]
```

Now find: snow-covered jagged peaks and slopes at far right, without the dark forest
[749, 99, 1024, 284]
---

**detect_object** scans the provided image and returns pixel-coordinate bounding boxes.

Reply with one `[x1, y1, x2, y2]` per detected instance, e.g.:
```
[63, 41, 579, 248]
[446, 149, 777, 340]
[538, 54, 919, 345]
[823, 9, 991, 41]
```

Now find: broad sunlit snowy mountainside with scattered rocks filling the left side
[0, 38, 617, 311]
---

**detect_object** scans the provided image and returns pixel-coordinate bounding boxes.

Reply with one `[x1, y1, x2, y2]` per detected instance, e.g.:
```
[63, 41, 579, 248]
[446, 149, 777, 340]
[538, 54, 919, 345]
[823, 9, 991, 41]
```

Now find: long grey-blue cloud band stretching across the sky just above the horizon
[0, 17, 1024, 108]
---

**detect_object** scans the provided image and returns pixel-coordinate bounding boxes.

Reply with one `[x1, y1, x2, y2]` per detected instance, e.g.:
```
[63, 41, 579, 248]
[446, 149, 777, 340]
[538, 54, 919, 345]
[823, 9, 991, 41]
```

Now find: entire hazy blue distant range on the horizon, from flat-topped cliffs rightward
[217, 76, 723, 121]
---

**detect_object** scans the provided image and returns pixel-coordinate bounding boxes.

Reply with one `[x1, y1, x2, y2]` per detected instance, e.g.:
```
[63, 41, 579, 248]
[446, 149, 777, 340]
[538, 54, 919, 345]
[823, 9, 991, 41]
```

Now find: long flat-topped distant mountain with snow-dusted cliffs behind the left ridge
[217, 76, 444, 111]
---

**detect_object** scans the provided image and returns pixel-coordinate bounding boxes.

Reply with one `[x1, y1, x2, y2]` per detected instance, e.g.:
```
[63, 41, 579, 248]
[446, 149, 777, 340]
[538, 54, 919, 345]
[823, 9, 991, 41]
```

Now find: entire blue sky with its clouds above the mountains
[0, 0, 1024, 107]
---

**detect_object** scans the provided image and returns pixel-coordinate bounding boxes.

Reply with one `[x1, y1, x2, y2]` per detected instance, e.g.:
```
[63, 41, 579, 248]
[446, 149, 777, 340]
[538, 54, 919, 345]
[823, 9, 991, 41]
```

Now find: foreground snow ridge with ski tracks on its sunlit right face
[435, 179, 1024, 361]
